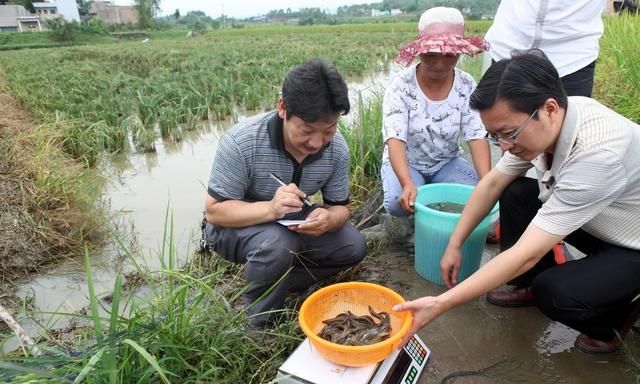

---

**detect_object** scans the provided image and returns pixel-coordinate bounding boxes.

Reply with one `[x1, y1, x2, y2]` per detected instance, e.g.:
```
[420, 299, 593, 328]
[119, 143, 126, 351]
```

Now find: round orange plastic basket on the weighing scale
[298, 282, 413, 367]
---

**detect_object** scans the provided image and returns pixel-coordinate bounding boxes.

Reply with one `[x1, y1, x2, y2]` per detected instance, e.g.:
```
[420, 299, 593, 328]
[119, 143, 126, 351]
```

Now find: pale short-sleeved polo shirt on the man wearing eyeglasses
[496, 96, 640, 250]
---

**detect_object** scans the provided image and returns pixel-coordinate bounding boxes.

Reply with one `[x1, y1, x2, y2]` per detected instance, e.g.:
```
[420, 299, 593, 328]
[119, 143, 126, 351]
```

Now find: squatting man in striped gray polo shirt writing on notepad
[205, 60, 366, 326]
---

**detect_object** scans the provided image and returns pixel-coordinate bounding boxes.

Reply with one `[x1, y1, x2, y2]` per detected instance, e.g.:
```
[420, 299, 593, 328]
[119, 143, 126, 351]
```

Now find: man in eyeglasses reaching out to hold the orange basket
[394, 50, 640, 353]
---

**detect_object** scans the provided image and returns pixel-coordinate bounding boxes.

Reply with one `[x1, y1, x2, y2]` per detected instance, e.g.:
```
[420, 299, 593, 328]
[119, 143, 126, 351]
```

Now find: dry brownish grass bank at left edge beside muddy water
[0, 108, 104, 280]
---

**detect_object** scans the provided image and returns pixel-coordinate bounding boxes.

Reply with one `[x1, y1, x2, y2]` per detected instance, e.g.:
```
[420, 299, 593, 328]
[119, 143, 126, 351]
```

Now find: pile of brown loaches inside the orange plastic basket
[318, 306, 391, 345]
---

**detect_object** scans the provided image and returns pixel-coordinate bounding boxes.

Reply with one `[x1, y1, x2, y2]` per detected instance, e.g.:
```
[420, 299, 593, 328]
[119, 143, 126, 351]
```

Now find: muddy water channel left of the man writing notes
[4, 120, 232, 352]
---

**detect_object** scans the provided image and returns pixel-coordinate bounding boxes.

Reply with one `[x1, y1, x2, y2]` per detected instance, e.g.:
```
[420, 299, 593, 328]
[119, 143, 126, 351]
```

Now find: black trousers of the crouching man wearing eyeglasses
[500, 177, 640, 341]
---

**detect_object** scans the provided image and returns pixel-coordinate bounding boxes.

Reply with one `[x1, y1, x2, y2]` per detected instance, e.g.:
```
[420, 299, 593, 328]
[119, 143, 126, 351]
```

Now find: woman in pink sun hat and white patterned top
[381, 7, 491, 216]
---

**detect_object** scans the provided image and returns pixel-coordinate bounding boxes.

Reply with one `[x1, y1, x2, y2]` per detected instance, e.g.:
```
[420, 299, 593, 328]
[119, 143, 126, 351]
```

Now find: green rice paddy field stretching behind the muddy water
[0, 24, 414, 166]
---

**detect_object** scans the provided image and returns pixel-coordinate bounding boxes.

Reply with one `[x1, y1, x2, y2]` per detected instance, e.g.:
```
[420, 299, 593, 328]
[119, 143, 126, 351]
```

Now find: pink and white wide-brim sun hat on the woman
[396, 7, 489, 67]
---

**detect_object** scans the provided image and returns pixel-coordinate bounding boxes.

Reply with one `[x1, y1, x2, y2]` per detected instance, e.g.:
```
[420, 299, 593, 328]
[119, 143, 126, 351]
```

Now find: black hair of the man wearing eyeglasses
[469, 49, 567, 114]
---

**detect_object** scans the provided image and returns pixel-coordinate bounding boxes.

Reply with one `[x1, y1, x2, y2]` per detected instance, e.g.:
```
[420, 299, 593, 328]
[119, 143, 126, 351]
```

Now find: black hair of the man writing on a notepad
[282, 59, 351, 122]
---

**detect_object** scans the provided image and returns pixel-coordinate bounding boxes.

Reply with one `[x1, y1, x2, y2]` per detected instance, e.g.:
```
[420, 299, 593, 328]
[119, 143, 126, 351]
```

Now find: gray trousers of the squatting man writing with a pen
[206, 222, 367, 326]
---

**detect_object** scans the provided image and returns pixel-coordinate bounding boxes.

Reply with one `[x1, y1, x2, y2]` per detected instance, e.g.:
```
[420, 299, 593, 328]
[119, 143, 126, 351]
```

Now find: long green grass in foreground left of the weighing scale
[0, 215, 301, 384]
